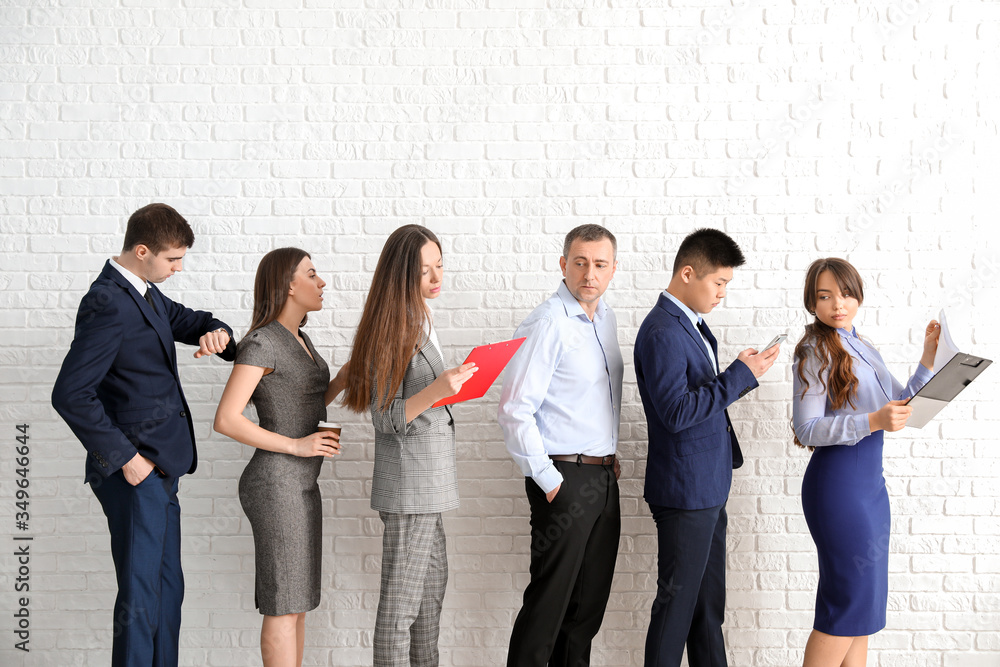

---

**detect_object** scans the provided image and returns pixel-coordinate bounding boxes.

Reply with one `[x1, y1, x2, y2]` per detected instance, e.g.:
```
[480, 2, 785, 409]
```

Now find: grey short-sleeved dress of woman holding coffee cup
[236, 322, 330, 616]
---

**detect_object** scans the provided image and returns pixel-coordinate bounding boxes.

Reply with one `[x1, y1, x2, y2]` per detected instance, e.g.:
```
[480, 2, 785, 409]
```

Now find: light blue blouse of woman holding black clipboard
[792, 328, 934, 447]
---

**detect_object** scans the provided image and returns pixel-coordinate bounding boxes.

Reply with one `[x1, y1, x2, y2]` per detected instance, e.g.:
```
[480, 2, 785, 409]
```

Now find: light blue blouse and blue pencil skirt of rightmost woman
[792, 329, 933, 637]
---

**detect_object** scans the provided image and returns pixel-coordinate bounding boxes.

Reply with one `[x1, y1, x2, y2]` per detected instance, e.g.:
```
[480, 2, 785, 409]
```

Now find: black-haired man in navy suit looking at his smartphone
[634, 229, 778, 667]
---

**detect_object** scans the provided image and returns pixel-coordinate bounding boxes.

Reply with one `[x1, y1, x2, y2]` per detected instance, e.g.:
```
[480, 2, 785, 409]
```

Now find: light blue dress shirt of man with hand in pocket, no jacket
[497, 283, 625, 493]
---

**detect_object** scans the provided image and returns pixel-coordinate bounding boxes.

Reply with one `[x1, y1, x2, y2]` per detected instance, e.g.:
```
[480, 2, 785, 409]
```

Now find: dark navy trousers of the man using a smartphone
[645, 504, 727, 667]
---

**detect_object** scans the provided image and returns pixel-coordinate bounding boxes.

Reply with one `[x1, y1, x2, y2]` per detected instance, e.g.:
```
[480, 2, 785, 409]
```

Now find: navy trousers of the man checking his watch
[91, 469, 184, 667]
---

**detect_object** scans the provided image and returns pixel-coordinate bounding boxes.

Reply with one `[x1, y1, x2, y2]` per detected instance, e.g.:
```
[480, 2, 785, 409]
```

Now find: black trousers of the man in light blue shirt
[507, 461, 622, 667]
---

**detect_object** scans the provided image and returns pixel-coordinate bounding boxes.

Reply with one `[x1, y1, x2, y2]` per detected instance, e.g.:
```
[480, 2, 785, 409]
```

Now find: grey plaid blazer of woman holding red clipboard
[371, 340, 458, 514]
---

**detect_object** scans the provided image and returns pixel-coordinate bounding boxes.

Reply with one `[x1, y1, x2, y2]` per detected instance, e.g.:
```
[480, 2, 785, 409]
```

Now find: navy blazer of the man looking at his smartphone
[634, 294, 757, 510]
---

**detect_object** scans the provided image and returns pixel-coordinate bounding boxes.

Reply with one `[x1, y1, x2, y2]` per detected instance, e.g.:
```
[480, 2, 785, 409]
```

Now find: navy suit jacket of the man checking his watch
[52, 262, 236, 482]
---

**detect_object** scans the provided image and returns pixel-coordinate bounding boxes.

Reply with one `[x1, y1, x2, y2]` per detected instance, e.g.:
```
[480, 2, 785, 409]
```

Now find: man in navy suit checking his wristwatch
[52, 204, 236, 667]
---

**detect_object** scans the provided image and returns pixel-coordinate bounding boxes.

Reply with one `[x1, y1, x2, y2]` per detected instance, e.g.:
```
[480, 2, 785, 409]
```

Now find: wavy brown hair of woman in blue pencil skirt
[795, 257, 865, 447]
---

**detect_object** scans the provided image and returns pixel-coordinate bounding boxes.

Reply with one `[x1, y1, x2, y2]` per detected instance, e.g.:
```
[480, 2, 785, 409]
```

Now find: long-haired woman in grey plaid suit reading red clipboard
[344, 225, 476, 667]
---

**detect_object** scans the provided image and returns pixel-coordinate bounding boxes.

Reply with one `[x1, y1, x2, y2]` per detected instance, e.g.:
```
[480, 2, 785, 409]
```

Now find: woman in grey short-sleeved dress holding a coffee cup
[215, 248, 346, 667]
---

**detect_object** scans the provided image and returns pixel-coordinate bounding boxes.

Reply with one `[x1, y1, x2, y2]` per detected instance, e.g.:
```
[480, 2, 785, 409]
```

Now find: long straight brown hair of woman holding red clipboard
[344, 225, 441, 412]
